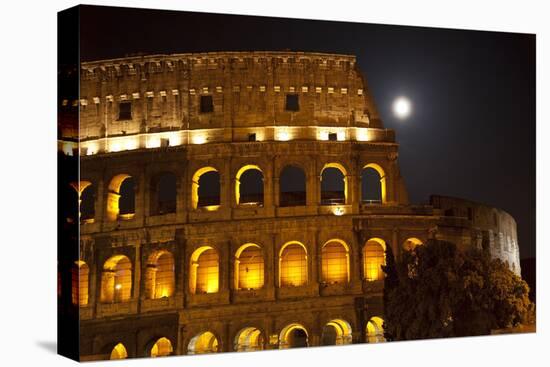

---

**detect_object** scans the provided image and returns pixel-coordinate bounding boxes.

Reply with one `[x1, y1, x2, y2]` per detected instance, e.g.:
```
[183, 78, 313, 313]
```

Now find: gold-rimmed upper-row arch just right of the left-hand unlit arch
[191, 167, 221, 210]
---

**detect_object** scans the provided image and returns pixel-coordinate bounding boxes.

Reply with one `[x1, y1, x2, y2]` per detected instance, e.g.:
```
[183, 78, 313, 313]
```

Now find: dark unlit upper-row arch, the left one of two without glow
[151, 172, 177, 215]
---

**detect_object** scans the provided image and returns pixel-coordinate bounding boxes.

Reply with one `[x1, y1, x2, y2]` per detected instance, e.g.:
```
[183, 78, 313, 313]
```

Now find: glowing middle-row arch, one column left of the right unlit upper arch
[235, 243, 264, 289]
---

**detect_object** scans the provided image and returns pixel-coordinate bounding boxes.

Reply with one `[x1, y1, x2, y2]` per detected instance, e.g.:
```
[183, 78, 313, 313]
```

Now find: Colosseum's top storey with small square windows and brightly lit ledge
[59, 51, 395, 155]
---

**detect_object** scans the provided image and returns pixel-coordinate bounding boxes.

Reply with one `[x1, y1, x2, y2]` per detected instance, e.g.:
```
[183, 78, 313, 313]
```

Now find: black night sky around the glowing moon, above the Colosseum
[80, 6, 535, 258]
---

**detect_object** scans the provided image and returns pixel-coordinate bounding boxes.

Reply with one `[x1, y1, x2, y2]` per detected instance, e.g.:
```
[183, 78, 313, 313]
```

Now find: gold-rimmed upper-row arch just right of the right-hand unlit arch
[321, 163, 348, 205]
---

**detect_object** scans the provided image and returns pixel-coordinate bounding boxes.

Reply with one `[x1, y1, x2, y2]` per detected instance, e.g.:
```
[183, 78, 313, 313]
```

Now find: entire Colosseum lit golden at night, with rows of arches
[58, 52, 520, 360]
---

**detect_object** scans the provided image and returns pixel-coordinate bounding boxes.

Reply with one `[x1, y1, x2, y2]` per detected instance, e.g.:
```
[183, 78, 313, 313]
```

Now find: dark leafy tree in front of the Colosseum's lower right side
[384, 240, 534, 340]
